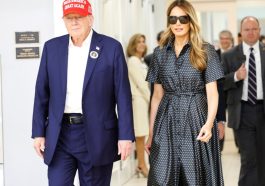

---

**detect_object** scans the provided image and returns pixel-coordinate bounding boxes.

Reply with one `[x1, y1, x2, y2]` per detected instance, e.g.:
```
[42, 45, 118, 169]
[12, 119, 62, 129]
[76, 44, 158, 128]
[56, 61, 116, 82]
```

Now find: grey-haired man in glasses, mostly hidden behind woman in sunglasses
[216, 30, 233, 151]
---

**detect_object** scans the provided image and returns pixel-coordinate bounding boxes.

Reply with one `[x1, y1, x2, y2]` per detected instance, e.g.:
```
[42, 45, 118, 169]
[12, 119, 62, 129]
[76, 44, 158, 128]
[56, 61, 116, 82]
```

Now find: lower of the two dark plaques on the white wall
[16, 47, 40, 59]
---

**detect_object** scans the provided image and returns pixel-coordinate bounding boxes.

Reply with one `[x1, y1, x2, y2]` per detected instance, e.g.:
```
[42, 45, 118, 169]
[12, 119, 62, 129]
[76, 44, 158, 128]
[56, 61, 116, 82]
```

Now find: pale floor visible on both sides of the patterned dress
[124, 128, 240, 186]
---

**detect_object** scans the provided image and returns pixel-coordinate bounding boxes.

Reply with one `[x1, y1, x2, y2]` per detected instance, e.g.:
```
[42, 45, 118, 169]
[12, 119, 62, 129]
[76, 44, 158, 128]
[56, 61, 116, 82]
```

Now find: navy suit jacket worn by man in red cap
[32, 31, 135, 165]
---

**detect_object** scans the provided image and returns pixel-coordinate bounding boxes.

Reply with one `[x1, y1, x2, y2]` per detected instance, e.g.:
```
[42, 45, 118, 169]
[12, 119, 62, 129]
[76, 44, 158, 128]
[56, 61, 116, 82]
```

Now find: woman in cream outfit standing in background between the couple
[127, 34, 150, 177]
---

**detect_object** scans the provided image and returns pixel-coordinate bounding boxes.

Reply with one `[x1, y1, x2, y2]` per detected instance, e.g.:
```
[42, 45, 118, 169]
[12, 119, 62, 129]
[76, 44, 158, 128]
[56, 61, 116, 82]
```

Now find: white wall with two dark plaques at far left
[0, 0, 54, 186]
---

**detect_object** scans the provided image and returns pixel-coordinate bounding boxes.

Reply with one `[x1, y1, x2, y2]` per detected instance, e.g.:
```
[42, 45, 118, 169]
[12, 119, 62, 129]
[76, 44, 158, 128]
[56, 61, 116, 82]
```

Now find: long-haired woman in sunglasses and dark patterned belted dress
[146, 0, 224, 186]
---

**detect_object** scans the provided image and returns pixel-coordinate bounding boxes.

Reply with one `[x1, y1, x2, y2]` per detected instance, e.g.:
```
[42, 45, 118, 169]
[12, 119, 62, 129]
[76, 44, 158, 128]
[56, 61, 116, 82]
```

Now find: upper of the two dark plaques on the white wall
[16, 32, 39, 44]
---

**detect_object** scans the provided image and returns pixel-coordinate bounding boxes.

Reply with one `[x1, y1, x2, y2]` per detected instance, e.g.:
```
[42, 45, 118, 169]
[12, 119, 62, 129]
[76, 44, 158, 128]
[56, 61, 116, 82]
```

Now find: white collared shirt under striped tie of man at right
[235, 41, 263, 101]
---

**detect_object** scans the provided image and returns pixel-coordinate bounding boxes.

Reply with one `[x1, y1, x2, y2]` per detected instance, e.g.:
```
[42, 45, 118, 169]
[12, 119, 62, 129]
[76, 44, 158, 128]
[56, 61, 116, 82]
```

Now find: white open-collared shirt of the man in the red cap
[64, 29, 93, 113]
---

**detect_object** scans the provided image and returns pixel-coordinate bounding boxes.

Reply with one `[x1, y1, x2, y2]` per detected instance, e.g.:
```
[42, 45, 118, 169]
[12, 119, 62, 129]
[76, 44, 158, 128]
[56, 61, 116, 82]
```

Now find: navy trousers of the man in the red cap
[48, 124, 113, 186]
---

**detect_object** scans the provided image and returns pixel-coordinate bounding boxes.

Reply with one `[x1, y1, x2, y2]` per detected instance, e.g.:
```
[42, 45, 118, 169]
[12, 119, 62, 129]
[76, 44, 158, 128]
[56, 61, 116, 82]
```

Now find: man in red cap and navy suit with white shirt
[32, 0, 135, 186]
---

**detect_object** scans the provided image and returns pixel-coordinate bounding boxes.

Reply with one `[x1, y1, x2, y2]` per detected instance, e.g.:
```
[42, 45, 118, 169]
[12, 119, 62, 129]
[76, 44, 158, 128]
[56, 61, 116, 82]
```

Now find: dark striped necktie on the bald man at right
[248, 47, 257, 104]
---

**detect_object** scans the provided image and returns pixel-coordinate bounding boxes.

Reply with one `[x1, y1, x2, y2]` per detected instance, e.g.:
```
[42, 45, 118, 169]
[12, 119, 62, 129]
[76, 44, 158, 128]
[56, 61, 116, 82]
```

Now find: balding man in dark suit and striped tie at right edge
[222, 16, 265, 186]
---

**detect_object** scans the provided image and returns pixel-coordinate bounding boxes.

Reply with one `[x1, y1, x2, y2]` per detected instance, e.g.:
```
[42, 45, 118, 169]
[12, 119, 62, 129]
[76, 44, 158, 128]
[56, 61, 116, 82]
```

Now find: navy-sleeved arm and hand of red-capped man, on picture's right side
[114, 43, 135, 160]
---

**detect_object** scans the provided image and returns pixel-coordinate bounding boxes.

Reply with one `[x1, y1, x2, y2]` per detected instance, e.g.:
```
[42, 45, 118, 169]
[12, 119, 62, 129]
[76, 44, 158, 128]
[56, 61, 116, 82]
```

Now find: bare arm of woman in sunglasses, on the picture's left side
[145, 84, 164, 154]
